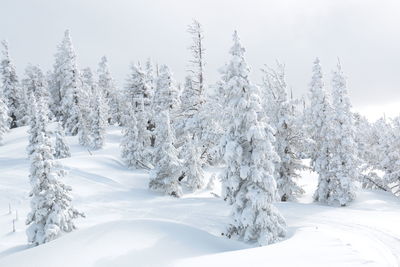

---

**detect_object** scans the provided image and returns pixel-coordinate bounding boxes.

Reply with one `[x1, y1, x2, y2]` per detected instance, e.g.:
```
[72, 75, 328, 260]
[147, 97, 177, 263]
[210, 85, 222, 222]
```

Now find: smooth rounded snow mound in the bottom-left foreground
[0, 220, 247, 267]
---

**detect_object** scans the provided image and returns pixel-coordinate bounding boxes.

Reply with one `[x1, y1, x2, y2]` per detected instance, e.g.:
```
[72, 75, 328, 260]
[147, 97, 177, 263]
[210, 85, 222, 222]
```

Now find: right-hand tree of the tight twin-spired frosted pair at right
[315, 63, 359, 206]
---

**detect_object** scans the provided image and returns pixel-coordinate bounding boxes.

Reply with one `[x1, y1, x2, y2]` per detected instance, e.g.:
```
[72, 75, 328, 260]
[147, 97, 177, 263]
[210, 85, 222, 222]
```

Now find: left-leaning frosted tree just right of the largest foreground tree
[263, 63, 306, 201]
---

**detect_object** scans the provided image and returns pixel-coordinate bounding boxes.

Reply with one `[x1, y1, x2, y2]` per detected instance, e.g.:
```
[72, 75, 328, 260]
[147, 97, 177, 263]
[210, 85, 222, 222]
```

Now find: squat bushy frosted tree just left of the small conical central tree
[121, 100, 151, 169]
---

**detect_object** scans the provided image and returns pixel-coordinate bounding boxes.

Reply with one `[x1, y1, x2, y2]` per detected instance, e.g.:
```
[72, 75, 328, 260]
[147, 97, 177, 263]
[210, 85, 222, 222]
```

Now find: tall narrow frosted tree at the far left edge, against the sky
[0, 40, 24, 128]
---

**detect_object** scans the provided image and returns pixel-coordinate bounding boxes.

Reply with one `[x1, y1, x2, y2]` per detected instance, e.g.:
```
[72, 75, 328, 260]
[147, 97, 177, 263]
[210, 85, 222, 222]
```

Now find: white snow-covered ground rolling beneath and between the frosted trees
[0, 127, 400, 267]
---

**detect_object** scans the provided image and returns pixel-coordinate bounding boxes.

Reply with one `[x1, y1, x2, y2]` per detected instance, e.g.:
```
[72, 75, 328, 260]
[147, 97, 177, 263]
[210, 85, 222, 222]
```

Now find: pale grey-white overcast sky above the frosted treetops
[0, 0, 400, 119]
